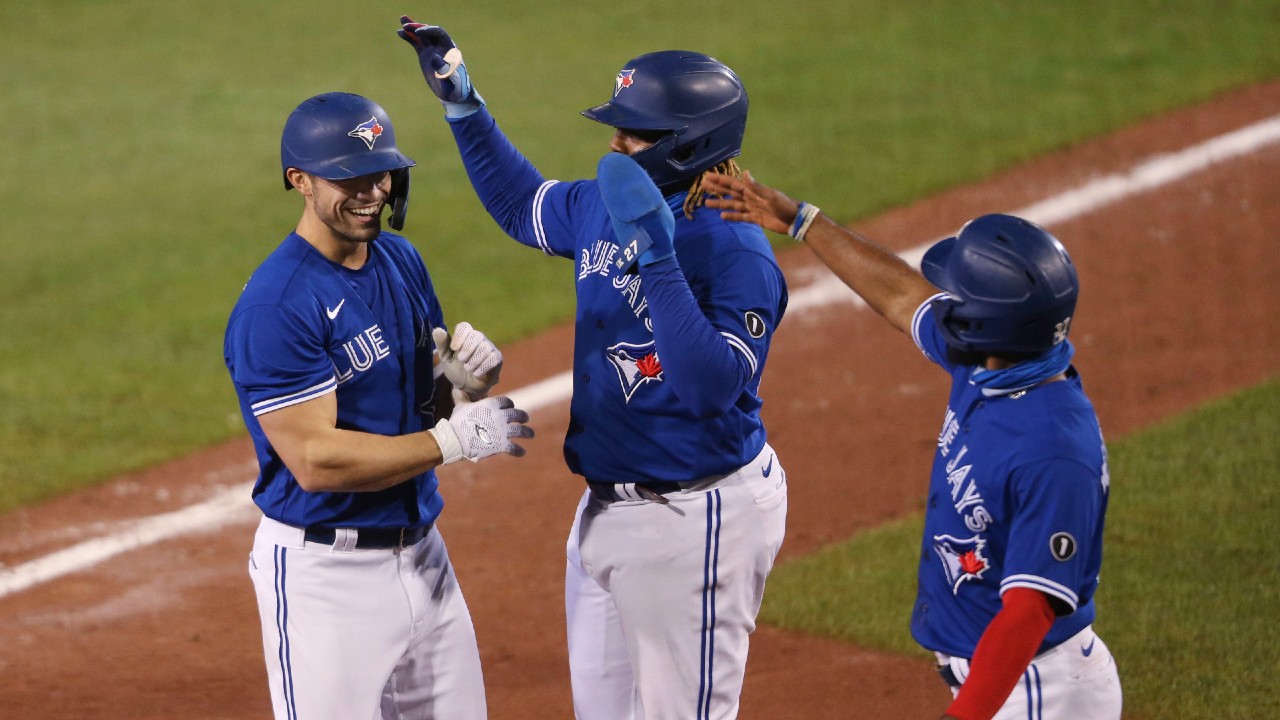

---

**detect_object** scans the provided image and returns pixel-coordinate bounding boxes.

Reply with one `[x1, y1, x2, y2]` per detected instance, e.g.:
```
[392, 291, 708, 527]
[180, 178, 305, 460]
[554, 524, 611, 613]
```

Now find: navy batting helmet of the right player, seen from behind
[920, 215, 1080, 352]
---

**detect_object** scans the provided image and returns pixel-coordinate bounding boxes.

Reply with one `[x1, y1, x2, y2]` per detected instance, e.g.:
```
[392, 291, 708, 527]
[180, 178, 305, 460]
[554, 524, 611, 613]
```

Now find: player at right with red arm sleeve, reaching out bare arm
[704, 169, 1120, 720]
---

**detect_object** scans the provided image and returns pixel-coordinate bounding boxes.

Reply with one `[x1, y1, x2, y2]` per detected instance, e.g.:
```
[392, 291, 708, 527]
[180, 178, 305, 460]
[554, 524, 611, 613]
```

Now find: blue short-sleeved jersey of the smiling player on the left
[223, 232, 444, 528]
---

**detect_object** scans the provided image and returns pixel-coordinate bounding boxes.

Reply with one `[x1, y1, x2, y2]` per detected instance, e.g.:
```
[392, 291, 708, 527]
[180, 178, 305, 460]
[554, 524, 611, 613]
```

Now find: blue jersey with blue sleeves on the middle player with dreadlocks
[449, 109, 787, 482]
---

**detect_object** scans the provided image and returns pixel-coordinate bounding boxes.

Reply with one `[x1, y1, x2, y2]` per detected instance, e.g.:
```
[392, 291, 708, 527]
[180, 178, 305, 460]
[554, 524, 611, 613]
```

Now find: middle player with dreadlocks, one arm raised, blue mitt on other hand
[399, 18, 787, 720]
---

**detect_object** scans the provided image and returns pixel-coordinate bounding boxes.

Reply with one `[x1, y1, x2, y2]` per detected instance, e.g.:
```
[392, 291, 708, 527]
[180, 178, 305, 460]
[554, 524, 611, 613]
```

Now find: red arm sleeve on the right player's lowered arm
[947, 588, 1055, 720]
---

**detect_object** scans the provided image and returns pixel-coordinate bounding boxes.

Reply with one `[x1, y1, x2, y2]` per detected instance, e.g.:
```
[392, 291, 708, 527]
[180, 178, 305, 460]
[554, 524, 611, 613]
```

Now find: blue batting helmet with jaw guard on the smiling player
[280, 92, 415, 229]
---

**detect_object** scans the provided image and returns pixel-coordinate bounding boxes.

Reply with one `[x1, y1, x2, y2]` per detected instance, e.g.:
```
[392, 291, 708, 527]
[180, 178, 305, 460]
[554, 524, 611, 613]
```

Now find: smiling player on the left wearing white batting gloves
[223, 92, 532, 720]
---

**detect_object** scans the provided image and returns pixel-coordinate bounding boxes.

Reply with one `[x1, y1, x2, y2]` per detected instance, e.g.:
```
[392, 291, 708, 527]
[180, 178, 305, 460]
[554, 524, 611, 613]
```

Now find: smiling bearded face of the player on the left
[288, 168, 392, 263]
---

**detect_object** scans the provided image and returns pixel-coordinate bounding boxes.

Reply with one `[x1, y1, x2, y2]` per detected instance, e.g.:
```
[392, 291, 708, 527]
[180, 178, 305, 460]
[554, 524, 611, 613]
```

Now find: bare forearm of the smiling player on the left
[293, 429, 442, 492]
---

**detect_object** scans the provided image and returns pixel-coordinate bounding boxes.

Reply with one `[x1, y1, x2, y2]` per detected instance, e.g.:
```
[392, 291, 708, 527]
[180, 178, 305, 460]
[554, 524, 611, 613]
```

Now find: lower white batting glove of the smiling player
[428, 396, 534, 465]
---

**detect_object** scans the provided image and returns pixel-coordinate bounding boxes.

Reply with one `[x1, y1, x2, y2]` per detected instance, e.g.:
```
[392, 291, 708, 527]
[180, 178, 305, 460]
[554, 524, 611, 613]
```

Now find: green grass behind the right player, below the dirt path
[760, 380, 1280, 720]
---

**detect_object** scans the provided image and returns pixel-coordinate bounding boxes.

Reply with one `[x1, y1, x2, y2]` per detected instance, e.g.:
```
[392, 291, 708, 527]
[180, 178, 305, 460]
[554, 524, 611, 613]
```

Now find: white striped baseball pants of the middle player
[564, 445, 787, 720]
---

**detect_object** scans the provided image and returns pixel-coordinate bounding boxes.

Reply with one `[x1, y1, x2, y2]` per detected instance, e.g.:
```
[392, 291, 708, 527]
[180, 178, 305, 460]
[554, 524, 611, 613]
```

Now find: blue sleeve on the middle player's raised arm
[448, 108, 545, 247]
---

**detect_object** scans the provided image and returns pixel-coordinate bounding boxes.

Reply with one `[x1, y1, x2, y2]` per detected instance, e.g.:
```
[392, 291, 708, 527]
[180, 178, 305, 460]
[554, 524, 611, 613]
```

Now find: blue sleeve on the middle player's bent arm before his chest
[640, 258, 755, 418]
